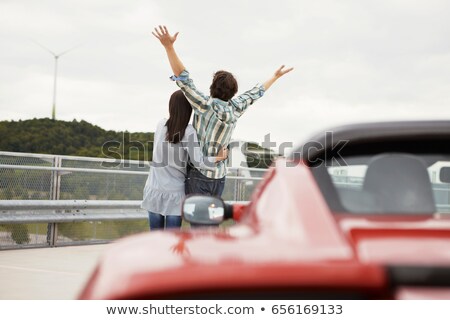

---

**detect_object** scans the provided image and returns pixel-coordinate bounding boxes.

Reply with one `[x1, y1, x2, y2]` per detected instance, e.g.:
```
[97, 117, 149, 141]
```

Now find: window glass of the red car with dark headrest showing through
[313, 153, 450, 214]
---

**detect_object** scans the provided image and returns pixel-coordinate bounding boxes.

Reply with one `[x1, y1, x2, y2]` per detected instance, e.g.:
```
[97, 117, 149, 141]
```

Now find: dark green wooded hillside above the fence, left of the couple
[0, 118, 153, 160]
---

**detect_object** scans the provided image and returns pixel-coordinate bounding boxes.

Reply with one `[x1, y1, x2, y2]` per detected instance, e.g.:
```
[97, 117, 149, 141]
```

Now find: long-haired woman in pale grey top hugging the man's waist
[141, 90, 228, 230]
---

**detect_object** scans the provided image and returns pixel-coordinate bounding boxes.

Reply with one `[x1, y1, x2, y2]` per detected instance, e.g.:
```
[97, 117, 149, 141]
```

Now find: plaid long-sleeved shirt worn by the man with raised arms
[171, 70, 265, 179]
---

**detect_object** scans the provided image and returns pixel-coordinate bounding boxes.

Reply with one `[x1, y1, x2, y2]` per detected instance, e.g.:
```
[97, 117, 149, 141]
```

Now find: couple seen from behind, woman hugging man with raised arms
[142, 26, 293, 230]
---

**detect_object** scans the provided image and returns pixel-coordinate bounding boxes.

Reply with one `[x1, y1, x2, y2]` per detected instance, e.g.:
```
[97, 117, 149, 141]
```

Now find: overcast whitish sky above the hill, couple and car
[0, 0, 450, 151]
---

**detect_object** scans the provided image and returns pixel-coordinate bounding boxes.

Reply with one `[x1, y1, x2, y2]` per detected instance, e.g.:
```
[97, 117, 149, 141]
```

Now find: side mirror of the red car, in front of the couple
[182, 195, 227, 225]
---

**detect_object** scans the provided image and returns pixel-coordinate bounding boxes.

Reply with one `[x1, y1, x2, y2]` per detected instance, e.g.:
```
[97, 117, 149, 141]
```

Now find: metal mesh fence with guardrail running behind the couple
[0, 152, 266, 249]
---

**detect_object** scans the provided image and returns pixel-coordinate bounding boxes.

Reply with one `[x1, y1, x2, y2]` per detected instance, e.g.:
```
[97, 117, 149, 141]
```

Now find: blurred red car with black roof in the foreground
[79, 121, 450, 299]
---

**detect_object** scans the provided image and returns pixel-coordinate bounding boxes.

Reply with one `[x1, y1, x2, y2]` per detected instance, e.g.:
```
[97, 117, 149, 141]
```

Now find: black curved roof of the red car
[292, 120, 450, 165]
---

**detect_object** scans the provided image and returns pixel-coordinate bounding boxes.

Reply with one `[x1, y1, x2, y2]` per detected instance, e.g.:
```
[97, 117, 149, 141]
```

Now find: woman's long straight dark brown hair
[166, 90, 192, 143]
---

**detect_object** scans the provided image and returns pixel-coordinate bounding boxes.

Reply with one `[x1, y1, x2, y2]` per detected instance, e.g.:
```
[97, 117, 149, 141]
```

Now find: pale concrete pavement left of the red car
[0, 245, 108, 300]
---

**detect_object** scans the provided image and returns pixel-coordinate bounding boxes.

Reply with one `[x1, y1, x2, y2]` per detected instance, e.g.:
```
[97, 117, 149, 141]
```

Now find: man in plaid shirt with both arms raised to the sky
[152, 26, 293, 196]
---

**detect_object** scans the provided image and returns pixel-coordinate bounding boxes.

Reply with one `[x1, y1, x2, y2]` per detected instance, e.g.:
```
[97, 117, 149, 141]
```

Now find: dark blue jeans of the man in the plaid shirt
[184, 167, 225, 197]
